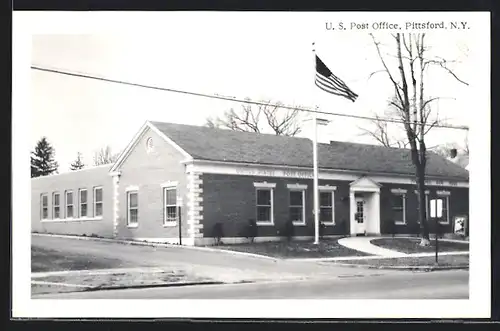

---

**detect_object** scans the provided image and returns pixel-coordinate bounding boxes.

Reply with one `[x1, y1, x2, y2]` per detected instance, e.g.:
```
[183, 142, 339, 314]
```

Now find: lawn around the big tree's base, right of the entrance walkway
[371, 237, 469, 254]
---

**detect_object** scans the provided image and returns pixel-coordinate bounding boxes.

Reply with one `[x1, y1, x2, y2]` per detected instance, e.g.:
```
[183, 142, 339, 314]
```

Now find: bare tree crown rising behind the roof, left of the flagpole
[206, 99, 301, 136]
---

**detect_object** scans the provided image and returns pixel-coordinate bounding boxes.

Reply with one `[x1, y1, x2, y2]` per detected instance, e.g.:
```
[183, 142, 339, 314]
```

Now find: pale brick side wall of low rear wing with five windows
[31, 165, 113, 237]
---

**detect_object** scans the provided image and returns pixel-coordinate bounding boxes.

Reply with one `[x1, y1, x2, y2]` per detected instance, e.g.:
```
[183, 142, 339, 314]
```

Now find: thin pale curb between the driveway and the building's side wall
[31, 232, 279, 261]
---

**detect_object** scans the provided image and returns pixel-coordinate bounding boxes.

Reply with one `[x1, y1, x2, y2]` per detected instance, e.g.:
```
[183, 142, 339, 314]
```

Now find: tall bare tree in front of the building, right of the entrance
[370, 33, 467, 246]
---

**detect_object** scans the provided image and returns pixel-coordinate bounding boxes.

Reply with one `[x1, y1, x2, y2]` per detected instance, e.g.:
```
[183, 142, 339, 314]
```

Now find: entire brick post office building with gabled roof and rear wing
[32, 122, 469, 245]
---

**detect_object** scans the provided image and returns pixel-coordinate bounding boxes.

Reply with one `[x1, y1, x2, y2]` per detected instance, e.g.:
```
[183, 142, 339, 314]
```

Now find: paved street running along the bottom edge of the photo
[34, 270, 469, 299]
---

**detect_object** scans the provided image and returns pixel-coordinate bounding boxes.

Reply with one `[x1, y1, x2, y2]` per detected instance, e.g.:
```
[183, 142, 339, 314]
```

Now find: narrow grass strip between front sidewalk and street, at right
[332, 254, 469, 267]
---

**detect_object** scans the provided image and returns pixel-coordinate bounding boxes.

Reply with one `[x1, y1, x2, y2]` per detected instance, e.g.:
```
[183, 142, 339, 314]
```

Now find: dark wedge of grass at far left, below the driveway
[31, 246, 127, 272]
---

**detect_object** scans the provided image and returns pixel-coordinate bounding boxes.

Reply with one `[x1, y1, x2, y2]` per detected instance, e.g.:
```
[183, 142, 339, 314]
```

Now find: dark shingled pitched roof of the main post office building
[150, 122, 469, 180]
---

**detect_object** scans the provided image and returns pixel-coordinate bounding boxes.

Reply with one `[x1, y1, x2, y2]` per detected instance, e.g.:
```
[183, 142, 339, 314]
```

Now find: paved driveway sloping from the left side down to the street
[32, 236, 400, 282]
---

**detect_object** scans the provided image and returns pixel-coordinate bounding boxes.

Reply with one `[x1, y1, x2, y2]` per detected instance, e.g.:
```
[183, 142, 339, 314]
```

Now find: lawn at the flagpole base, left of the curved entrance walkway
[214, 239, 370, 259]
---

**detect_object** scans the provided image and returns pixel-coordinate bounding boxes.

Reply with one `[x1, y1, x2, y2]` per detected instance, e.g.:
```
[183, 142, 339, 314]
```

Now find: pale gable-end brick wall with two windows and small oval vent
[117, 129, 188, 244]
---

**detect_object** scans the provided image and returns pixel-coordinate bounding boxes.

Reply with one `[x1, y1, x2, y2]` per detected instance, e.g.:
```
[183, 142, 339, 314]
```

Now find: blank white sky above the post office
[30, 15, 472, 172]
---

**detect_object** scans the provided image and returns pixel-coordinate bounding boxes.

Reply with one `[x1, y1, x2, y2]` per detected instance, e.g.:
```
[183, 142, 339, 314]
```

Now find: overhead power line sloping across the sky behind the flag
[31, 65, 469, 130]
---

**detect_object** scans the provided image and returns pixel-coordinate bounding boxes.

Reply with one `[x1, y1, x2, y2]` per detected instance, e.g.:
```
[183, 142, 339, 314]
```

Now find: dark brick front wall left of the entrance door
[201, 173, 349, 237]
